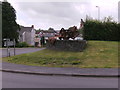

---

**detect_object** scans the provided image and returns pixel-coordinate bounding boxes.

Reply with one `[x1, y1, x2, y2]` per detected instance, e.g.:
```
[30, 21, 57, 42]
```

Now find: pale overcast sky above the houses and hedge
[4, 0, 120, 30]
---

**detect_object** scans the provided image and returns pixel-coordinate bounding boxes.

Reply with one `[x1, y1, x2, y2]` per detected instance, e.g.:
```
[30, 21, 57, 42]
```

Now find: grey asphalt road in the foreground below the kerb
[2, 72, 118, 88]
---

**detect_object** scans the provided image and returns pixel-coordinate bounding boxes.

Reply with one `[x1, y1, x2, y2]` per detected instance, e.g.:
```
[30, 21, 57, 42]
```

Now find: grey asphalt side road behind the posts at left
[0, 48, 44, 57]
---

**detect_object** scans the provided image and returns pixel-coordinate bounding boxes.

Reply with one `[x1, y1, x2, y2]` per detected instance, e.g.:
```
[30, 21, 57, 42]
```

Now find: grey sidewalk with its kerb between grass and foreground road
[0, 62, 120, 77]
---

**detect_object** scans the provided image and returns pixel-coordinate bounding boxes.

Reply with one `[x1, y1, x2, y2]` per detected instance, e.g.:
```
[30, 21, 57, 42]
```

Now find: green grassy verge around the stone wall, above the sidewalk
[3, 41, 118, 68]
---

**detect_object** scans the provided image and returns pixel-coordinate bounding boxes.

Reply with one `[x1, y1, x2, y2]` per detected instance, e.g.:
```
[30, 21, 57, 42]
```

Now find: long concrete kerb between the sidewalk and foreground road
[0, 69, 120, 78]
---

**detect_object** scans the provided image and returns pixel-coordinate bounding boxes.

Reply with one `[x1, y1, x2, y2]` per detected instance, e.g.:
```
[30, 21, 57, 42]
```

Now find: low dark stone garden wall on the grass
[46, 40, 87, 52]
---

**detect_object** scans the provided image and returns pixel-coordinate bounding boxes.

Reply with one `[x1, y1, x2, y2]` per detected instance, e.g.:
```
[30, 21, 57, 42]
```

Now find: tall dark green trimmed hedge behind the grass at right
[83, 20, 120, 41]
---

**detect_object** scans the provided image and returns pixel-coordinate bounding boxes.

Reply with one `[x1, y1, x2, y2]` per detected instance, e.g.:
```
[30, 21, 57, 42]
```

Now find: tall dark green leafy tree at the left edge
[2, 1, 20, 41]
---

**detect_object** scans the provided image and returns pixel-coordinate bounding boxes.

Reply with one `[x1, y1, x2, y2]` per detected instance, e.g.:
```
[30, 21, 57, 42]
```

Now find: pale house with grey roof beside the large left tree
[18, 25, 35, 46]
